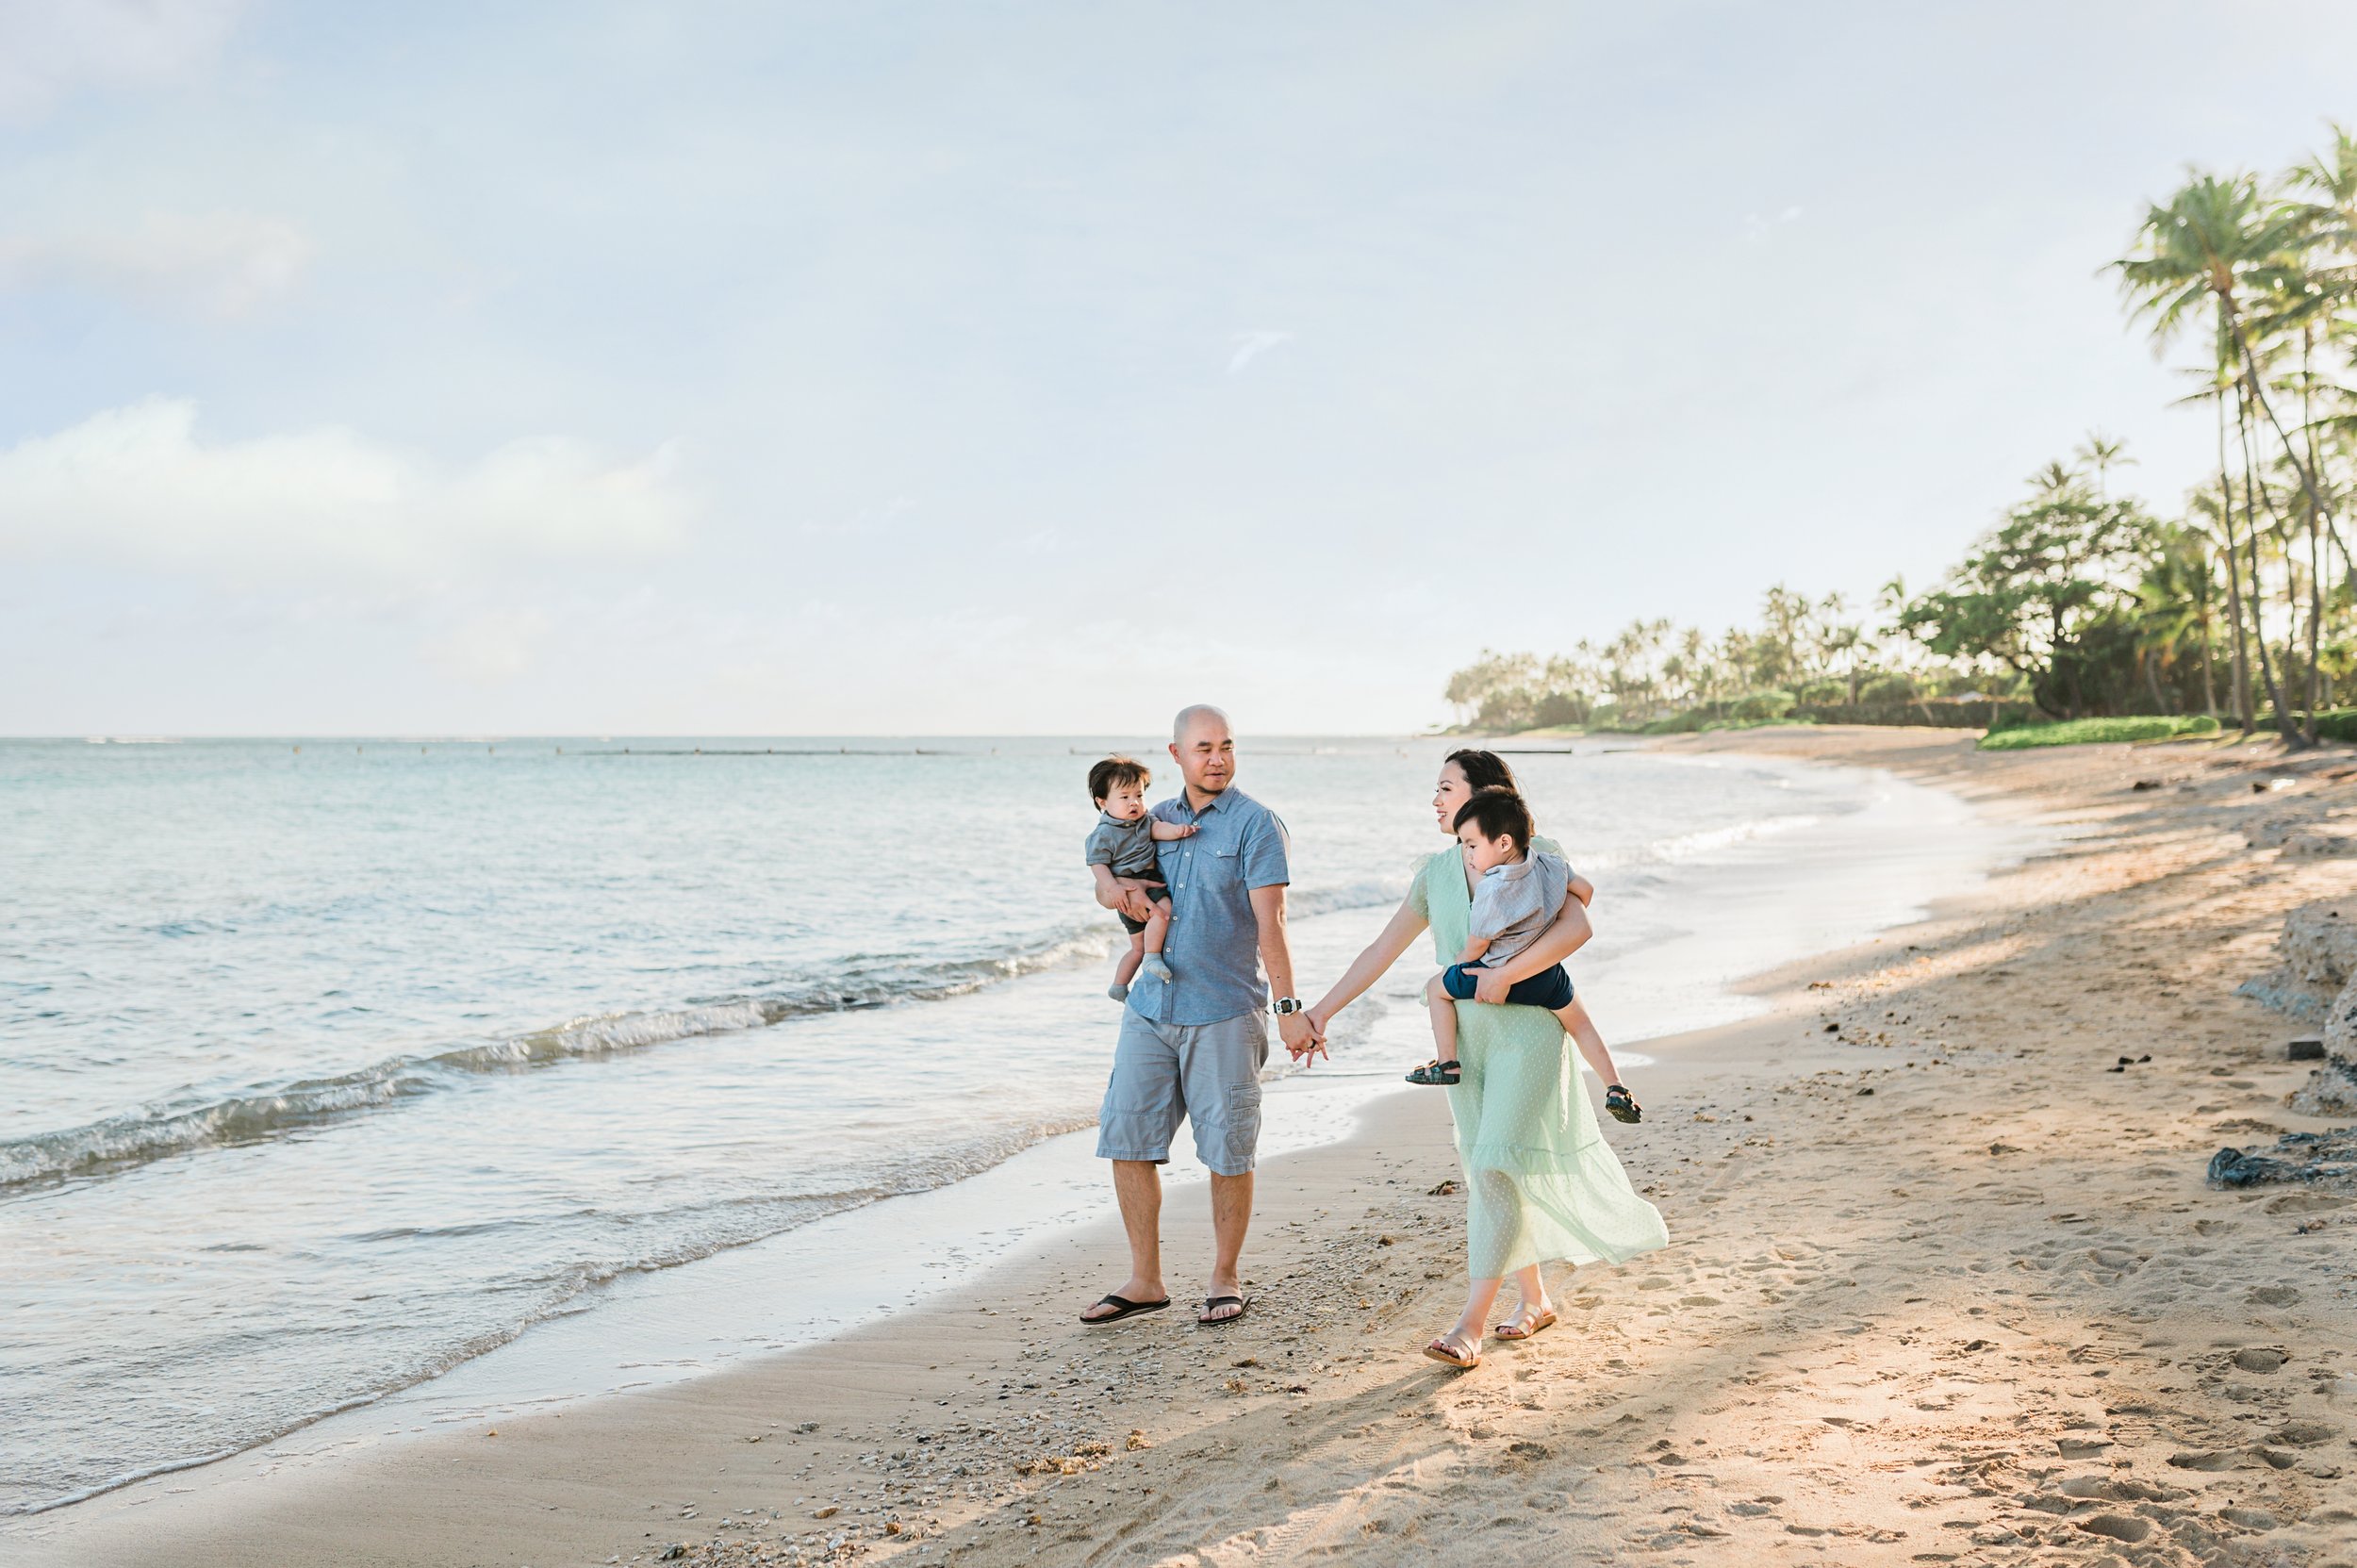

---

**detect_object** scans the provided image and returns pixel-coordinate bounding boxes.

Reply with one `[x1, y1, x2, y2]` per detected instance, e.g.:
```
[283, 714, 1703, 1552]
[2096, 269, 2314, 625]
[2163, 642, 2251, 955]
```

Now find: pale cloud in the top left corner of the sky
[0, 0, 245, 118]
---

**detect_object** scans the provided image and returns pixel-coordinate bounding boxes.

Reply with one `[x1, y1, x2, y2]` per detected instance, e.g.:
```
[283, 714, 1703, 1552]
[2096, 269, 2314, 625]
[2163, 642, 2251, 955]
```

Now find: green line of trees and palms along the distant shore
[1445, 125, 2357, 743]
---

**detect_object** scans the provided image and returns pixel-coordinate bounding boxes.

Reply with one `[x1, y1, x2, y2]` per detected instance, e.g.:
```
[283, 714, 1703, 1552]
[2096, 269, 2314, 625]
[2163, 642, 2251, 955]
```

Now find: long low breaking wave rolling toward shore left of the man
[0, 880, 1405, 1191]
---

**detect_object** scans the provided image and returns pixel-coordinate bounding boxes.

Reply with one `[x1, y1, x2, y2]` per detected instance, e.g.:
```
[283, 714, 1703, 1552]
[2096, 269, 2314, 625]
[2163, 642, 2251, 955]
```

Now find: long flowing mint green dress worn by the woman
[1409, 839, 1669, 1280]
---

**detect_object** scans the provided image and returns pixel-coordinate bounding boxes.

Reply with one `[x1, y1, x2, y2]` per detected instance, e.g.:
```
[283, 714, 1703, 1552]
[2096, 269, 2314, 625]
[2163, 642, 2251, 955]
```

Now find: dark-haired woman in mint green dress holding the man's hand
[1310, 750, 1669, 1367]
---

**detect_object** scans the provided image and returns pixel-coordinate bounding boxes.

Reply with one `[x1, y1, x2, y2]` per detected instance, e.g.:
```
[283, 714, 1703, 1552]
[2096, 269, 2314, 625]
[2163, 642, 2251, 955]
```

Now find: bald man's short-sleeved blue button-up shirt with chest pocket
[1129, 785, 1292, 1026]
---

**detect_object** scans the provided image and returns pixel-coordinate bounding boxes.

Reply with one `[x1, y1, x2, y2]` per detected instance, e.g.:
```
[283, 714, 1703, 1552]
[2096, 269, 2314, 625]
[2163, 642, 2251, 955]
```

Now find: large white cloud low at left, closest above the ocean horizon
[0, 399, 691, 583]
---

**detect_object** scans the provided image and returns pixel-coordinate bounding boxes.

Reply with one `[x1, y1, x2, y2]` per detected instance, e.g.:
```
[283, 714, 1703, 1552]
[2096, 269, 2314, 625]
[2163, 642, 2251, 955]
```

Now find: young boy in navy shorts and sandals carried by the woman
[1408, 787, 1643, 1122]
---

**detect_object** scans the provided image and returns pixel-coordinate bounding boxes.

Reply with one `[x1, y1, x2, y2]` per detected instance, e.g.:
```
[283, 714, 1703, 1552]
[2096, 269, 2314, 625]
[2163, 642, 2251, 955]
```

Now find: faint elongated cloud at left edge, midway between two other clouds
[0, 212, 311, 316]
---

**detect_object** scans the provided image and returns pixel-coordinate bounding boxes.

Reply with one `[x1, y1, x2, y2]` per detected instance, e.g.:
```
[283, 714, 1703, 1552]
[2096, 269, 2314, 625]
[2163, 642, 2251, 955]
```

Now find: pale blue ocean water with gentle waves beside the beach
[0, 738, 1989, 1513]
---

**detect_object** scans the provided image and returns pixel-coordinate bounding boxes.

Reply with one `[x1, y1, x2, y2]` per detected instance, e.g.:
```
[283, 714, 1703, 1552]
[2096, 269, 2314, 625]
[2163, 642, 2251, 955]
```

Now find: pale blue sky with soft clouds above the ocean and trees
[0, 0, 2357, 735]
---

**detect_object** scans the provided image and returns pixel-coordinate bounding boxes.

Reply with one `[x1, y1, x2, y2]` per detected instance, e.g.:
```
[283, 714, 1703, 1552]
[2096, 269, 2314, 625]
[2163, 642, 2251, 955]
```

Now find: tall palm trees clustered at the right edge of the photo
[2115, 125, 2357, 740]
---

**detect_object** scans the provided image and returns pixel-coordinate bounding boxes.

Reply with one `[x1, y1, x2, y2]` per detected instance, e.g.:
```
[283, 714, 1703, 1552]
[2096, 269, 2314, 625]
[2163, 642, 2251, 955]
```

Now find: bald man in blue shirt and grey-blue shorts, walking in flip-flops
[1082, 705, 1318, 1325]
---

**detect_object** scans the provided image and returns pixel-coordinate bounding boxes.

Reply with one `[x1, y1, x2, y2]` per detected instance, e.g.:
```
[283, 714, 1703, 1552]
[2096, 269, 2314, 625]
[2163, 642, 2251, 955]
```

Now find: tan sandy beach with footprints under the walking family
[18, 731, 2357, 1568]
